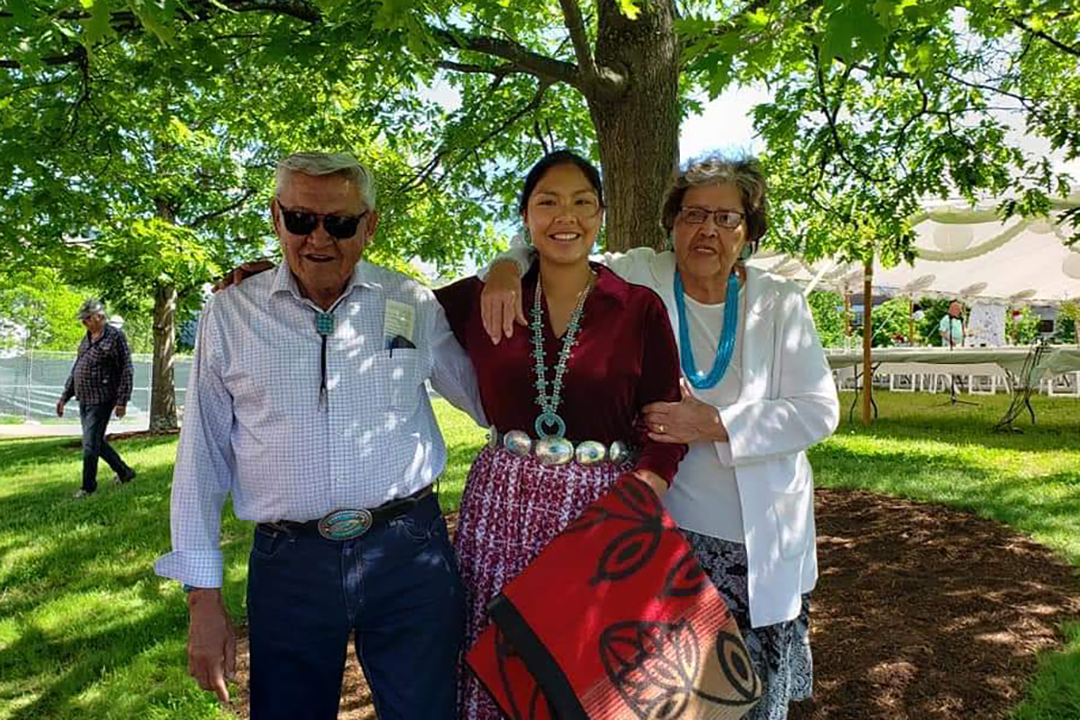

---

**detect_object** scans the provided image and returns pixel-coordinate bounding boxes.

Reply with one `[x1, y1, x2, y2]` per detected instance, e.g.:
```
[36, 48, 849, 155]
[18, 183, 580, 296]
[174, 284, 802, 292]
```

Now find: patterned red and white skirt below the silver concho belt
[454, 448, 632, 720]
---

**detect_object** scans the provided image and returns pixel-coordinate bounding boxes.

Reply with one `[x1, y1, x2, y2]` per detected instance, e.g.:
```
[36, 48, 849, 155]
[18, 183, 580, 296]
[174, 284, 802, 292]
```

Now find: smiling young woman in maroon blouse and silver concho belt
[436, 151, 686, 720]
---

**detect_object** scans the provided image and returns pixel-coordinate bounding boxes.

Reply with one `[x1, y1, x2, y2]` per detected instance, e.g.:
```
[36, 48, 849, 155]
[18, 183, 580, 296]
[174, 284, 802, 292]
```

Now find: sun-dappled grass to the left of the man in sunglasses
[0, 438, 251, 720]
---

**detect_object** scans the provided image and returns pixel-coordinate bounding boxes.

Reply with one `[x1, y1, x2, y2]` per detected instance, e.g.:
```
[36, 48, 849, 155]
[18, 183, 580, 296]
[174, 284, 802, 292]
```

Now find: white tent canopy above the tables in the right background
[751, 193, 1080, 304]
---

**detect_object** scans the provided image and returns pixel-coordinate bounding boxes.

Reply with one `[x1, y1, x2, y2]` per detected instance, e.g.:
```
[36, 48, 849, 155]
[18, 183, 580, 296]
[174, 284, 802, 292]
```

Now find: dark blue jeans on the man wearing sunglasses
[247, 494, 464, 720]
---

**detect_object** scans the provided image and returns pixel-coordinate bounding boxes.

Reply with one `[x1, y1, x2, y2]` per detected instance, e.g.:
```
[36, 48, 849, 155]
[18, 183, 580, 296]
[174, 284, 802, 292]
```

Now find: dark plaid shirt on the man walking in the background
[60, 325, 134, 406]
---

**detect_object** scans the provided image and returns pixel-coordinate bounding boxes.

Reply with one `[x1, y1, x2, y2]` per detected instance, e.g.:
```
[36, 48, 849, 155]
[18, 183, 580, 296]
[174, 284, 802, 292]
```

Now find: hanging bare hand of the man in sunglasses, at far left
[188, 589, 237, 705]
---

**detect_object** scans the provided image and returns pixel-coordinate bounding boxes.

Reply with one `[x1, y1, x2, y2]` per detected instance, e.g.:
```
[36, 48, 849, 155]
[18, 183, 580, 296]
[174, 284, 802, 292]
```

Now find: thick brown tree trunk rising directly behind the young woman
[586, 0, 679, 252]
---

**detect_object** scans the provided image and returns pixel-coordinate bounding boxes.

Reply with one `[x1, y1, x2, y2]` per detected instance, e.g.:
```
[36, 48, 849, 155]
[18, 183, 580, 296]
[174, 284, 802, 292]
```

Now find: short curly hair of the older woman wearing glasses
[660, 154, 769, 248]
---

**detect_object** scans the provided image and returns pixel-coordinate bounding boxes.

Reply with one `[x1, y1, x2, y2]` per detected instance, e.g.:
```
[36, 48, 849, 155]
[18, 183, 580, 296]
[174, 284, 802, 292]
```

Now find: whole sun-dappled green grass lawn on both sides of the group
[0, 394, 1080, 720]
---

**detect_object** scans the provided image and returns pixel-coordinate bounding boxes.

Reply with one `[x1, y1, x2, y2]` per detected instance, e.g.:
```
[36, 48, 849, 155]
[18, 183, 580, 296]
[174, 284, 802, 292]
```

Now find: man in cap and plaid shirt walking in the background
[56, 298, 135, 500]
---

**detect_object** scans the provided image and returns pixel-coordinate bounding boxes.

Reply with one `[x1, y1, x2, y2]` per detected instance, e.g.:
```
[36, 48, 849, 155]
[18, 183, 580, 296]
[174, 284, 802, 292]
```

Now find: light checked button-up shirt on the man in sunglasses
[154, 262, 486, 587]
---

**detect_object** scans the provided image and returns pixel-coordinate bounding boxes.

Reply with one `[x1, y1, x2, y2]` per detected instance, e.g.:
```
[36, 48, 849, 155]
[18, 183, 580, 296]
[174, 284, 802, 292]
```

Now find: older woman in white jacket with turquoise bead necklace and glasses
[482, 158, 839, 720]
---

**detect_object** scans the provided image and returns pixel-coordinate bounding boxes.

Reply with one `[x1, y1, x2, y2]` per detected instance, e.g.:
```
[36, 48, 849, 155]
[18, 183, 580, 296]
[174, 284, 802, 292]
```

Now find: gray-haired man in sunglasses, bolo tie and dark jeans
[156, 153, 484, 720]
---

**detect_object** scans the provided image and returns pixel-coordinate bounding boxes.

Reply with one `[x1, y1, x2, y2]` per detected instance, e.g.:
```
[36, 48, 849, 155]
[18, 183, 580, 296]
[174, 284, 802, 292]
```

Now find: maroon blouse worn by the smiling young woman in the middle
[435, 263, 687, 485]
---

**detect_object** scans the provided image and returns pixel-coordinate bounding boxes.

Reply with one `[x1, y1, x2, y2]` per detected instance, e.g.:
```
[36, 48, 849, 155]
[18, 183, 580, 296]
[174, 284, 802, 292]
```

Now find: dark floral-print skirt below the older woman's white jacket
[683, 530, 813, 720]
